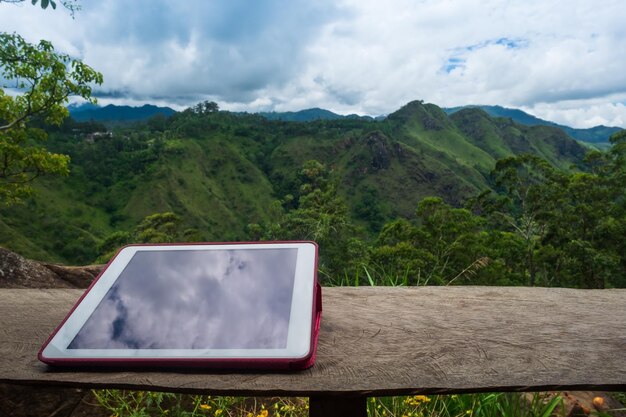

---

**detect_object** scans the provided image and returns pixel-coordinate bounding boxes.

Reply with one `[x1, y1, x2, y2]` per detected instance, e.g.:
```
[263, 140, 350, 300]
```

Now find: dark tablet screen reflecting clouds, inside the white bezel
[68, 249, 297, 349]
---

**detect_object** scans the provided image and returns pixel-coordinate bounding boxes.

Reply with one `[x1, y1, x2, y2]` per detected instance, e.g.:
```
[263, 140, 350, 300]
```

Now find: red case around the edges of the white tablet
[37, 241, 322, 370]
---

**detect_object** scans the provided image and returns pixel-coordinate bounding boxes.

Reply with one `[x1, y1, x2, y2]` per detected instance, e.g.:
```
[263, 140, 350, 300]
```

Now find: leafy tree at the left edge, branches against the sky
[0, 33, 102, 205]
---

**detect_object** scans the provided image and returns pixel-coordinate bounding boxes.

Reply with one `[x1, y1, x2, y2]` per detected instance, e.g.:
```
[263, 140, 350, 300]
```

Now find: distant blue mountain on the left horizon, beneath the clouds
[68, 103, 176, 122]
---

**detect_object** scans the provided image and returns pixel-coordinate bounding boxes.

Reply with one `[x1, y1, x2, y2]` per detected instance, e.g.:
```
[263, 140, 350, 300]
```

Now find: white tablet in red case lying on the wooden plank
[39, 242, 321, 369]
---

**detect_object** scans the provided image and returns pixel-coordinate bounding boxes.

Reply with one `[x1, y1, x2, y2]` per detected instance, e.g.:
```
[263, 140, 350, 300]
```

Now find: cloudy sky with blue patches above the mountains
[0, 0, 626, 127]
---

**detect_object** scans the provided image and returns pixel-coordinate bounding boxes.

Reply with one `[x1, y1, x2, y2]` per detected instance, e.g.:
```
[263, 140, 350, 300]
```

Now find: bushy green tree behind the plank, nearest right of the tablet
[370, 197, 519, 285]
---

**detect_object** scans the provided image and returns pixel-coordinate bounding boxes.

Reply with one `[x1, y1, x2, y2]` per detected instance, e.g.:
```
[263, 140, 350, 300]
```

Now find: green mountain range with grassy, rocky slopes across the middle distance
[0, 101, 586, 264]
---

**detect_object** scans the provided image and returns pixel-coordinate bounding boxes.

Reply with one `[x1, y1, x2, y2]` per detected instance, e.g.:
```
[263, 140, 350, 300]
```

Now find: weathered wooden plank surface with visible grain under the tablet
[0, 286, 626, 397]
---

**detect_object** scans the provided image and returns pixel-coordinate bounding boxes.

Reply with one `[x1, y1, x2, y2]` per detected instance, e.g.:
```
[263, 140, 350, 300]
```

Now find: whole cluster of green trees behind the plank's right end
[473, 145, 626, 288]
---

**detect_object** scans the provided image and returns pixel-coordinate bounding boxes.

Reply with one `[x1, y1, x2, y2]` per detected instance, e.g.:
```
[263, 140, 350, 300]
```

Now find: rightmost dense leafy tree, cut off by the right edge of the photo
[545, 131, 626, 288]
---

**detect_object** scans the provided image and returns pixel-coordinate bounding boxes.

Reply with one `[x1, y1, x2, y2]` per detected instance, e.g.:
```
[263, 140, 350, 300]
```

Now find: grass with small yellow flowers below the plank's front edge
[94, 390, 563, 417]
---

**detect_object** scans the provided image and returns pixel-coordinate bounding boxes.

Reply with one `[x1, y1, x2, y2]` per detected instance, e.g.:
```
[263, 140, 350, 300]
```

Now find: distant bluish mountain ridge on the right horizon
[444, 105, 622, 149]
